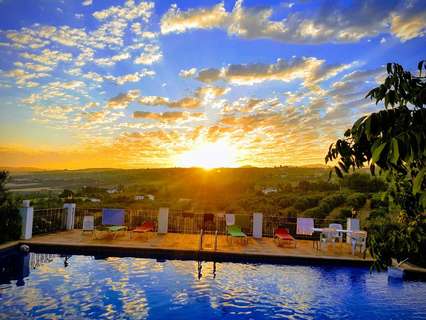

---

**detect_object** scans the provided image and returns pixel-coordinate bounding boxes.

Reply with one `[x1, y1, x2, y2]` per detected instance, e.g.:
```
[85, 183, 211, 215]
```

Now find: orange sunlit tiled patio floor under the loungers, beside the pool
[22, 230, 372, 263]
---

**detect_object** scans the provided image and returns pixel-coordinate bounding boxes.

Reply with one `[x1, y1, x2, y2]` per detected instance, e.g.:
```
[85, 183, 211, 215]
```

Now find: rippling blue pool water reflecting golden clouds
[0, 254, 426, 320]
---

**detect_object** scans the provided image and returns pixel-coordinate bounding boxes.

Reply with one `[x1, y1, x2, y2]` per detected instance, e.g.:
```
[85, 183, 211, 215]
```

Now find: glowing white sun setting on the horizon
[176, 141, 237, 169]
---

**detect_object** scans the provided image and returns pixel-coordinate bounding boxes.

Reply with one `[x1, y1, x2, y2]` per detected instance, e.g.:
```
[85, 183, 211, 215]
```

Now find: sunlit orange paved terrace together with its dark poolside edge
[21, 229, 373, 265]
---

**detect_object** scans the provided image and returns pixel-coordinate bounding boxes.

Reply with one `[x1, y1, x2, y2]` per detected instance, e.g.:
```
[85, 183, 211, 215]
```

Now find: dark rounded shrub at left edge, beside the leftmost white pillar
[0, 203, 21, 243]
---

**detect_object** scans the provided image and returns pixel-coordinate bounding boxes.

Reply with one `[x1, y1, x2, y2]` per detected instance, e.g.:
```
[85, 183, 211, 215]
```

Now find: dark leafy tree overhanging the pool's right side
[325, 60, 426, 268]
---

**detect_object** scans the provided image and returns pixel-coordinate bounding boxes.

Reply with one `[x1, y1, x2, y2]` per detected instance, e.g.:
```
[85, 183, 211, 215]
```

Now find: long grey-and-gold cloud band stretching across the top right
[161, 0, 426, 43]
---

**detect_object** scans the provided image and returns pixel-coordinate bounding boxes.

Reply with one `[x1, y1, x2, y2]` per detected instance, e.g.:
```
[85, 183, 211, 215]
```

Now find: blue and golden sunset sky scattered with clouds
[0, 0, 426, 169]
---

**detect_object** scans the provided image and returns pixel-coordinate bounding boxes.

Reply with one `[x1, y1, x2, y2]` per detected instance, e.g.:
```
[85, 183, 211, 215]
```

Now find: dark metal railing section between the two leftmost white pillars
[33, 208, 67, 234]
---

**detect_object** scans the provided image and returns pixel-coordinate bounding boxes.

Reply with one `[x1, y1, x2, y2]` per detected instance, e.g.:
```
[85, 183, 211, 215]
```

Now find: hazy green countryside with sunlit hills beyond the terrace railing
[7, 167, 387, 219]
